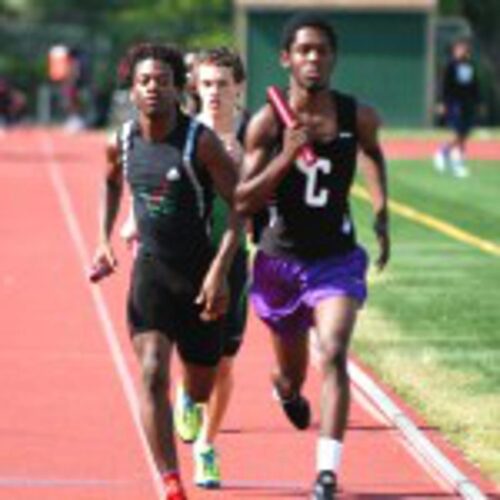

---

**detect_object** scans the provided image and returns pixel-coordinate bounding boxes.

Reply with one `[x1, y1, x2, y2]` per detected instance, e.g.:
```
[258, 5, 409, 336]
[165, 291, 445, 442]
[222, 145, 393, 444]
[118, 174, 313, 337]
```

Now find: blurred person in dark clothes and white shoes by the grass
[434, 38, 479, 178]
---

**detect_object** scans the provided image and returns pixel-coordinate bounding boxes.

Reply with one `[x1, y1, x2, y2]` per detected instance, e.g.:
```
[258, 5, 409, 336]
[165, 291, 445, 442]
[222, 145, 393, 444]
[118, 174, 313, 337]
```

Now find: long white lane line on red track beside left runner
[40, 133, 163, 498]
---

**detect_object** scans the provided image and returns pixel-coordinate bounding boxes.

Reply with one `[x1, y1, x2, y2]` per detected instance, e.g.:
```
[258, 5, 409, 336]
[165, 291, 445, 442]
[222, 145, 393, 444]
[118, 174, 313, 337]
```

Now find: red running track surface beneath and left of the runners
[0, 130, 492, 500]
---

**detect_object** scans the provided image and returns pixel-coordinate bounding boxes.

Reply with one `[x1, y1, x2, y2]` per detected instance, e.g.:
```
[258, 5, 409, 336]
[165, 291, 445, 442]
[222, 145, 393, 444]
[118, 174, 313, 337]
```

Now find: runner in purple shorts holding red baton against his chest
[236, 13, 389, 500]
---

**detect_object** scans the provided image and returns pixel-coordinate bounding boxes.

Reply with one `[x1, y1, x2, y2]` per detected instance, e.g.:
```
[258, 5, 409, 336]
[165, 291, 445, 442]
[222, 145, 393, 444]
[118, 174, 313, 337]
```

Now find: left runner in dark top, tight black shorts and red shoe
[90, 44, 239, 500]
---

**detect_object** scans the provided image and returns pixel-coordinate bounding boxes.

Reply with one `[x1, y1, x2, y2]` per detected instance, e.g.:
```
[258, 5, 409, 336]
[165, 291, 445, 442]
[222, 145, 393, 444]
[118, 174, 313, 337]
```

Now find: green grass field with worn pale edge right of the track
[353, 157, 500, 483]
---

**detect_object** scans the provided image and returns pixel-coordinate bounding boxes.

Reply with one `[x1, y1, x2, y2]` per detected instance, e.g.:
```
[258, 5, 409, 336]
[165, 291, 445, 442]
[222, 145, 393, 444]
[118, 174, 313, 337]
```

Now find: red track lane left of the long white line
[0, 131, 158, 500]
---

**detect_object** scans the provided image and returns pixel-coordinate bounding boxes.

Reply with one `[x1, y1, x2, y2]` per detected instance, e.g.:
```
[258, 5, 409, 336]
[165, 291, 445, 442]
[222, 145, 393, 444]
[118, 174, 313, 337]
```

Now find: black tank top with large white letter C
[260, 92, 358, 260]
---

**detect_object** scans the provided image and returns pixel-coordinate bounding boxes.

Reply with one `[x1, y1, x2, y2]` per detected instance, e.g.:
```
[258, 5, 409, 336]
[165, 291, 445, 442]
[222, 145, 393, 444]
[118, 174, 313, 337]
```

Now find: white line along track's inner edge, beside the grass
[349, 360, 486, 500]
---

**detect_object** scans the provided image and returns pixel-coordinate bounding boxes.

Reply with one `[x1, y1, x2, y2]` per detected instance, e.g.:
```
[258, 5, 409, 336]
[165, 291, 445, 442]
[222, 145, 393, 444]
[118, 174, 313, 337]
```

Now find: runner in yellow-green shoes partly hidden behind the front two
[174, 47, 248, 488]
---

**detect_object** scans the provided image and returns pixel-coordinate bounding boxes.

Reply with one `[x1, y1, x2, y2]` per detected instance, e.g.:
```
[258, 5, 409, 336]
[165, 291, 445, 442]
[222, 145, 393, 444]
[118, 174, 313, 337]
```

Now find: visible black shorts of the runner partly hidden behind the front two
[222, 247, 248, 357]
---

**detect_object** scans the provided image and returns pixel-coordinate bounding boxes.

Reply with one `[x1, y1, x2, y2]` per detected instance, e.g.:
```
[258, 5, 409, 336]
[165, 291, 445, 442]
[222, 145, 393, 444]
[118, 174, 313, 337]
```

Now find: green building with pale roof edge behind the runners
[234, 0, 437, 127]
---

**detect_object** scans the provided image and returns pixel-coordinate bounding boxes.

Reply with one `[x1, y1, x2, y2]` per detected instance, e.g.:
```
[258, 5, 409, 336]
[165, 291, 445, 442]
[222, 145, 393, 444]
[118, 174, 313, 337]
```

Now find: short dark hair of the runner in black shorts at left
[118, 42, 186, 89]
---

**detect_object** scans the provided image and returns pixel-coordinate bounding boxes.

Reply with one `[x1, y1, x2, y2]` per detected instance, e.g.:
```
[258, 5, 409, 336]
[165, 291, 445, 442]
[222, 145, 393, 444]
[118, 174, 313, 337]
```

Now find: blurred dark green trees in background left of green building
[0, 0, 233, 119]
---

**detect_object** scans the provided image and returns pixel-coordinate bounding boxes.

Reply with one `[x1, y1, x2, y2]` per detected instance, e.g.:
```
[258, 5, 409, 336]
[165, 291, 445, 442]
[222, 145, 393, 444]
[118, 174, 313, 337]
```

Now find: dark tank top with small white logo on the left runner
[119, 111, 217, 270]
